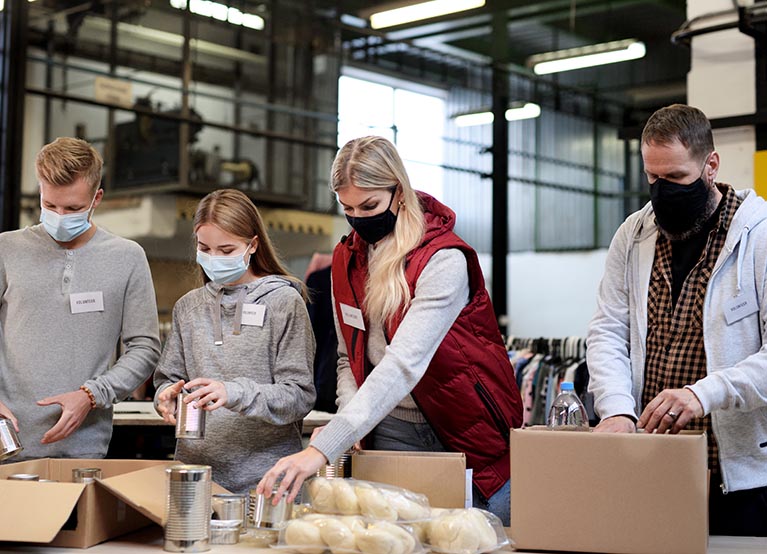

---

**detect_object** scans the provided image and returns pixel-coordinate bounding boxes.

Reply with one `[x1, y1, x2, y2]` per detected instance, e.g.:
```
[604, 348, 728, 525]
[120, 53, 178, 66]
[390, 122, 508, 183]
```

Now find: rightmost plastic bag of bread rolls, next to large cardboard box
[421, 508, 509, 554]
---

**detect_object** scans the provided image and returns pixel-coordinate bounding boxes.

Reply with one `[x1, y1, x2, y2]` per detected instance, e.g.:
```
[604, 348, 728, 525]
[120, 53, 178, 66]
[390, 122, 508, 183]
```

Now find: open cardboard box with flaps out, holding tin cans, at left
[0, 458, 226, 548]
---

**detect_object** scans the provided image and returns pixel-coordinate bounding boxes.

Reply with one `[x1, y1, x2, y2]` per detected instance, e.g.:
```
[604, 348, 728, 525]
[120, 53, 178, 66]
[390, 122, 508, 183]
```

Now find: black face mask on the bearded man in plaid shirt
[650, 161, 711, 235]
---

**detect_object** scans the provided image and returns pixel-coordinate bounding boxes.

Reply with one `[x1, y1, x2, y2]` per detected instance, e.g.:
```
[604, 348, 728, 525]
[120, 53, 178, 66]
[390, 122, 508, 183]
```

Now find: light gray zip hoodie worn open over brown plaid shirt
[587, 190, 767, 492]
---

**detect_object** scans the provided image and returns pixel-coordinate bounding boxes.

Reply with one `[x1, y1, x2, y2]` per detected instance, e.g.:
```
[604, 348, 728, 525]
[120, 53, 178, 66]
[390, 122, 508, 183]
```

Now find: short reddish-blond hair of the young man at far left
[35, 137, 104, 193]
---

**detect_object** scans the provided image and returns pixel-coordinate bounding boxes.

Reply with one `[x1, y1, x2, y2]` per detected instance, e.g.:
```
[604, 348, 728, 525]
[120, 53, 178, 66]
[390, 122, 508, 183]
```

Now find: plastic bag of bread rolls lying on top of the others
[304, 477, 430, 523]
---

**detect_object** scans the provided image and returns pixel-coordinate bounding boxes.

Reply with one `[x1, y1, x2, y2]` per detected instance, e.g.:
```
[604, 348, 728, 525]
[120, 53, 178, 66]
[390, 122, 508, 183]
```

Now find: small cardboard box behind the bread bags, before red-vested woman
[352, 450, 471, 508]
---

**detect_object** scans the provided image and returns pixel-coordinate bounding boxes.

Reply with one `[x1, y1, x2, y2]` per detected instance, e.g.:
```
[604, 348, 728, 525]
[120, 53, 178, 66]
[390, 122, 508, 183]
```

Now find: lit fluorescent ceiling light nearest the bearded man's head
[527, 39, 646, 75]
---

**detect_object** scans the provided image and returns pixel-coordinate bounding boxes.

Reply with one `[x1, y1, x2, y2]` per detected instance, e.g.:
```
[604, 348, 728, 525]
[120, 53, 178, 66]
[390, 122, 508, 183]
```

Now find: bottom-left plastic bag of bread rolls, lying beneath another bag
[273, 514, 424, 554]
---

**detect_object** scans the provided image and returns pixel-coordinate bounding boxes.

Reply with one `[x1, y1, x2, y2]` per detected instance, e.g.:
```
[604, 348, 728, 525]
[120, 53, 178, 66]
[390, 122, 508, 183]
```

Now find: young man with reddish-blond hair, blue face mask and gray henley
[0, 138, 160, 461]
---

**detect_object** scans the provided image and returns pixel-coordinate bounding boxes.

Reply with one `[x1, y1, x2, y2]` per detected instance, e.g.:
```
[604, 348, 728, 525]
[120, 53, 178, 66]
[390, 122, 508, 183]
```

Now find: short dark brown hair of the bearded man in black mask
[642, 104, 714, 163]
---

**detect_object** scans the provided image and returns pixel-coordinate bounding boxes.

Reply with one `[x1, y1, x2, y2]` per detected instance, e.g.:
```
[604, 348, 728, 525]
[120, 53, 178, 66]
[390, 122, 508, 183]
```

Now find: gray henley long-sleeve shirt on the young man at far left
[0, 225, 160, 462]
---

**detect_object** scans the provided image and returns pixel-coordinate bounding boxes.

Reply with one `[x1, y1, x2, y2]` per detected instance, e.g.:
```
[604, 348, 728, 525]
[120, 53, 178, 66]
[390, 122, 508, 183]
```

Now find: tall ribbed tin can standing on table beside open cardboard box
[163, 464, 212, 552]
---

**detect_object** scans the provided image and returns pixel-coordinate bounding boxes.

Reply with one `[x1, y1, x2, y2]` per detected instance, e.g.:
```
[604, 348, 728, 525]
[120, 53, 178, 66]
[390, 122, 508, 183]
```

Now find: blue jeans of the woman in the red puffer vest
[370, 416, 511, 527]
